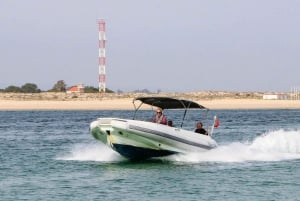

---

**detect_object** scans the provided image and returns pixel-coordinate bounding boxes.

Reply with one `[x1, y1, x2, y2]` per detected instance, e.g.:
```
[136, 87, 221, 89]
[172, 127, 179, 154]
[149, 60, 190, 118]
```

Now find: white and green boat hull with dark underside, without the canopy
[90, 118, 217, 160]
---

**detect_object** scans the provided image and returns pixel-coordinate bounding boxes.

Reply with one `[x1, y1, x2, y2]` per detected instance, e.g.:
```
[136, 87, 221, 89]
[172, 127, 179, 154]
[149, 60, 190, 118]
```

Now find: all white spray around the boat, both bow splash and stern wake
[57, 130, 300, 163]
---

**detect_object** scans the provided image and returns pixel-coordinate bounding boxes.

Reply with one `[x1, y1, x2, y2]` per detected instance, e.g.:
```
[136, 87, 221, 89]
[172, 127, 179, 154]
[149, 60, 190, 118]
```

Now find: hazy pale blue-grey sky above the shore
[0, 0, 300, 92]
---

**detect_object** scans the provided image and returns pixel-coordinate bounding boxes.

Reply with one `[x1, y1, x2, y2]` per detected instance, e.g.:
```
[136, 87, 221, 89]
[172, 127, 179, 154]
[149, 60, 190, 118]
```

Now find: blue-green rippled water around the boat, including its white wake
[0, 110, 300, 201]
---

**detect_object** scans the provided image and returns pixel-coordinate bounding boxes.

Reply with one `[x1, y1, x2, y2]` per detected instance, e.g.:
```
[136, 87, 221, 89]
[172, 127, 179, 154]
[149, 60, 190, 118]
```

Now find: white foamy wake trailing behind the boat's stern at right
[169, 130, 300, 163]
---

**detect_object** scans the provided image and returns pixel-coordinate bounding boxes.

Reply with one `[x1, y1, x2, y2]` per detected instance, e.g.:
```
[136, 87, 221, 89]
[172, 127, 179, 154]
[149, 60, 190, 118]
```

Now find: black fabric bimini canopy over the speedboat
[133, 97, 207, 109]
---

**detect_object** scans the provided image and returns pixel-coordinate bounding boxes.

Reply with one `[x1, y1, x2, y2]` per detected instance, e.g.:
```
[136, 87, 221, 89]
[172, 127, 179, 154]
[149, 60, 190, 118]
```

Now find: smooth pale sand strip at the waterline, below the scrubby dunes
[0, 98, 300, 111]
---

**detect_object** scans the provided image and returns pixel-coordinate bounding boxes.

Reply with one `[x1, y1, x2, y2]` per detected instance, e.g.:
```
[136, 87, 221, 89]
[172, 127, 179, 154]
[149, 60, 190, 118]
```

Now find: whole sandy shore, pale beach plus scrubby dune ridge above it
[0, 91, 300, 111]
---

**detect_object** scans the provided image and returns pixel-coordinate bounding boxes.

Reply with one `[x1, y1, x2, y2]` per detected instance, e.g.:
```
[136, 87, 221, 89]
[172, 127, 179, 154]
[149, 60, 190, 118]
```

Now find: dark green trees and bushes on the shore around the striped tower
[0, 80, 113, 93]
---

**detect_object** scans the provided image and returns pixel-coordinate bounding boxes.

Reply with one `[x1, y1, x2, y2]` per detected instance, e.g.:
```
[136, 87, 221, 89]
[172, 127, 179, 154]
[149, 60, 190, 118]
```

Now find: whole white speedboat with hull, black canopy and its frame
[90, 97, 217, 160]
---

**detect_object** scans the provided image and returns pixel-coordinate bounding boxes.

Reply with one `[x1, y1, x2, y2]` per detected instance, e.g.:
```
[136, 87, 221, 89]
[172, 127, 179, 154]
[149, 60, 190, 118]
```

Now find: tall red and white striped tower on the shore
[98, 20, 106, 92]
